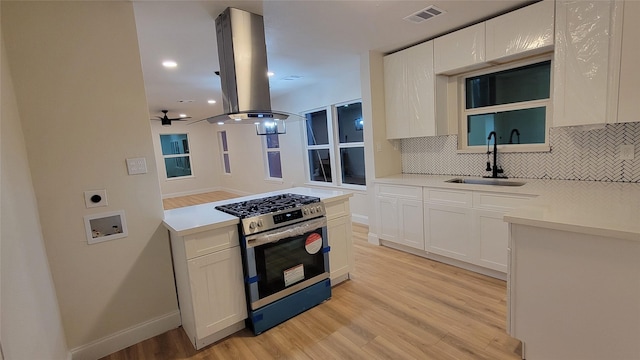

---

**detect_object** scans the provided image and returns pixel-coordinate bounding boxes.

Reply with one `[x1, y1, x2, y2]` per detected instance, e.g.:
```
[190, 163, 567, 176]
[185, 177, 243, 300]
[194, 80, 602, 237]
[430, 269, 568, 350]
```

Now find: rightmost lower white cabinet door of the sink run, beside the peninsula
[473, 210, 509, 272]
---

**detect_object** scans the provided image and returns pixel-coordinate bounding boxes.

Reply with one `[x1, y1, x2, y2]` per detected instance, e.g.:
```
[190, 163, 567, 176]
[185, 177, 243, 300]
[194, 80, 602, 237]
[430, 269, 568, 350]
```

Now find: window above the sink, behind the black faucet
[460, 59, 551, 151]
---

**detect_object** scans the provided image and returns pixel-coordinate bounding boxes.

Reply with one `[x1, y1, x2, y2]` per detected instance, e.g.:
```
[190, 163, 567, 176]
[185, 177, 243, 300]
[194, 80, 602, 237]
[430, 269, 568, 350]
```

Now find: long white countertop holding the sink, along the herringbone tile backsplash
[375, 174, 640, 241]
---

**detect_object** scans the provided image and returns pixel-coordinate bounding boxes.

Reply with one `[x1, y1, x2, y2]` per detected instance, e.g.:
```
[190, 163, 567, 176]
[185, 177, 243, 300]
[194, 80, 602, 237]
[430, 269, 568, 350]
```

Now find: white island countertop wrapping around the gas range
[162, 187, 353, 236]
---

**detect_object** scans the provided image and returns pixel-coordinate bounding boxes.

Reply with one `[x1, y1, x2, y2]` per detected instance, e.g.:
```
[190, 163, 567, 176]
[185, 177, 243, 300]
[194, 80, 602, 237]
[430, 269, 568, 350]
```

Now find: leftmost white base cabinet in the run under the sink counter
[376, 184, 424, 250]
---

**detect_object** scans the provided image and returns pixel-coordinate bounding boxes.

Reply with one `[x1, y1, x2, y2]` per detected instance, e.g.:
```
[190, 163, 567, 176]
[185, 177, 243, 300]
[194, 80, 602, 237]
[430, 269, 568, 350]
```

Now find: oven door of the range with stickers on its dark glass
[245, 217, 329, 310]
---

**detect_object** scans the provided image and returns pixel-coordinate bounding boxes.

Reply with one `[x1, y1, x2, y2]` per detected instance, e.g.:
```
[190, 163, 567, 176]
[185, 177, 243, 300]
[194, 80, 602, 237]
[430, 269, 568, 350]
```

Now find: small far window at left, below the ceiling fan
[160, 134, 192, 179]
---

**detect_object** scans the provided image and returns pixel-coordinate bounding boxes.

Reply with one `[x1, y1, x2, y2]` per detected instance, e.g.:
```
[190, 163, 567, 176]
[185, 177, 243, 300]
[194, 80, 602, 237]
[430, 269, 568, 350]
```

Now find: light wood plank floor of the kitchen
[104, 194, 521, 360]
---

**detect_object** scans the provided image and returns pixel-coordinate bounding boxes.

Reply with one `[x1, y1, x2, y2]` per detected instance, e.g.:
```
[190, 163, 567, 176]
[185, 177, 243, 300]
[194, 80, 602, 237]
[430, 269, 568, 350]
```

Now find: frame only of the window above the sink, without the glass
[457, 54, 554, 153]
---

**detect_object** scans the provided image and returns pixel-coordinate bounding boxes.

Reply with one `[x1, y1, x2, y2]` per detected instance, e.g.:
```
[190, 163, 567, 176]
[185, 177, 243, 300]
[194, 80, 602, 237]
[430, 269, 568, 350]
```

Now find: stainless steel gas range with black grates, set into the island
[216, 194, 331, 334]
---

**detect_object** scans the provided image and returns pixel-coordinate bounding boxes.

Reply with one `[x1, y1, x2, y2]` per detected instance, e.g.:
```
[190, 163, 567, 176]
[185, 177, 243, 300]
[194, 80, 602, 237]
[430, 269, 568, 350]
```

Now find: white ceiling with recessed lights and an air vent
[133, 0, 531, 121]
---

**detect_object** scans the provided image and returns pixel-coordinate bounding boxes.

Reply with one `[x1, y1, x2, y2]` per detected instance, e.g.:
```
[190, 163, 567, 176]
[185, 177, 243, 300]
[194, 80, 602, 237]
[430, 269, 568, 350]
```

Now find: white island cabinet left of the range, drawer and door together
[170, 225, 247, 349]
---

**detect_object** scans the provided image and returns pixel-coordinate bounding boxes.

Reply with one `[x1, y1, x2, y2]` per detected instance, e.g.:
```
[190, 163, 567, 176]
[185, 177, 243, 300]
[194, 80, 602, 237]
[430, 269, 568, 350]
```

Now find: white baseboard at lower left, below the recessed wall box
[71, 310, 181, 360]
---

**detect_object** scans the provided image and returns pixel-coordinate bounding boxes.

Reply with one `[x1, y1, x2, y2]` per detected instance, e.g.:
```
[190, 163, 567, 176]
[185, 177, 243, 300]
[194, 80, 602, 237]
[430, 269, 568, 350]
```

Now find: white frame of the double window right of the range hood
[302, 99, 367, 191]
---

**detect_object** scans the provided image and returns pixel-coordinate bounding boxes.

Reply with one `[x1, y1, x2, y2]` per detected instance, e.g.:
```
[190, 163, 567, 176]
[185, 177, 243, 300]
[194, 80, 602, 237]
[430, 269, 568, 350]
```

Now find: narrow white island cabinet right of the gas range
[323, 198, 353, 285]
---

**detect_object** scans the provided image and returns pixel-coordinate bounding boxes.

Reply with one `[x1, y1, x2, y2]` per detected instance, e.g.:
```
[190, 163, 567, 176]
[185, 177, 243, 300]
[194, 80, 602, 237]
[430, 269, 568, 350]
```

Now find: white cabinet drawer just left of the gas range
[184, 225, 239, 259]
